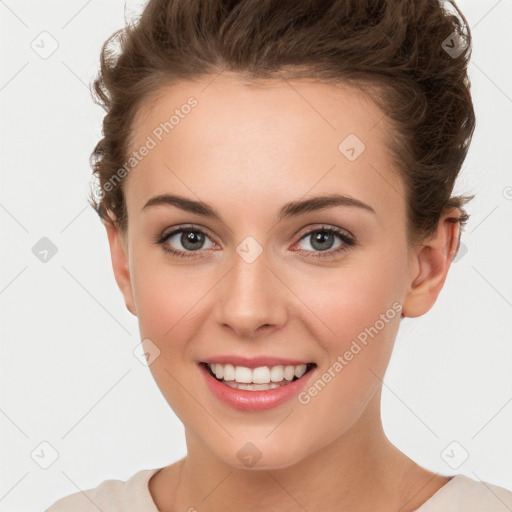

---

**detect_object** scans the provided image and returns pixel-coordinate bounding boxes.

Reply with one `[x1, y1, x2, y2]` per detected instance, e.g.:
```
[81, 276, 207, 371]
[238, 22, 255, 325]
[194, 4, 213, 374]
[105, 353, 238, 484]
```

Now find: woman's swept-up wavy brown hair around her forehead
[89, 0, 475, 248]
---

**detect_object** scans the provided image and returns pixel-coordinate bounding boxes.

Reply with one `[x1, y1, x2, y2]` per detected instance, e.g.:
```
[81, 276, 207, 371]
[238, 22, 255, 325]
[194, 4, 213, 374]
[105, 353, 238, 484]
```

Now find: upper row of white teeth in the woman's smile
[208, 363, 307, 389]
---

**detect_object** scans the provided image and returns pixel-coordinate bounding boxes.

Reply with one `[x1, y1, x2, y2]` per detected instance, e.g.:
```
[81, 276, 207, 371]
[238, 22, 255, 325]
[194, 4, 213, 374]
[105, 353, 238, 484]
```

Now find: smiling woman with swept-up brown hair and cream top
[48, 0, 512, 512]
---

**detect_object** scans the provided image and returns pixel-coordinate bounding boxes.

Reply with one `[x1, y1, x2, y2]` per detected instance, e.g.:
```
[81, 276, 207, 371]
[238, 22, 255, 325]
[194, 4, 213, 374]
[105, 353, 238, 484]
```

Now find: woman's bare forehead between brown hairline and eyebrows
[125, 75, 403, 220]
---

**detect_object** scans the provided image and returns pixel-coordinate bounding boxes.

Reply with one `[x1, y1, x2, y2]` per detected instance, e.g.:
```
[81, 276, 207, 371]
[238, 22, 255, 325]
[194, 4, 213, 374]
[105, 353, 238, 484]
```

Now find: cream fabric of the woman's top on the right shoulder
[415, 475, 512, 512]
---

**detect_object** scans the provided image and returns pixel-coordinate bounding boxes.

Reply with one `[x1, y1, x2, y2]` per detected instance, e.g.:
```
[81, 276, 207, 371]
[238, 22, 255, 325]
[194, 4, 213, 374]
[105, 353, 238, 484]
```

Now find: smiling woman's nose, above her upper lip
[216, 248, 291, 339]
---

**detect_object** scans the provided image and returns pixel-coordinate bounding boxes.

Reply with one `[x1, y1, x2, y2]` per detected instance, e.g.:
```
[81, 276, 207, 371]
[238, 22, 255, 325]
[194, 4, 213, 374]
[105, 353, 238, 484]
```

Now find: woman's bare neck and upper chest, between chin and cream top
[153, 390, 446, 512]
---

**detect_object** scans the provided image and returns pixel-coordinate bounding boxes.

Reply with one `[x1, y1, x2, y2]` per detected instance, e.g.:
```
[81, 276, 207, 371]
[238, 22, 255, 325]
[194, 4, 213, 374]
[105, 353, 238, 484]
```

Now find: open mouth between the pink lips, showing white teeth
[199, 362, 317, 391]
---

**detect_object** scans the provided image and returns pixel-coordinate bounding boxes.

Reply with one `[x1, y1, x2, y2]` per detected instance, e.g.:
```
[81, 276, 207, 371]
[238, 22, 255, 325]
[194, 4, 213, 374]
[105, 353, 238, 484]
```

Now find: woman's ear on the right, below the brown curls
[402, 208, 461, 317]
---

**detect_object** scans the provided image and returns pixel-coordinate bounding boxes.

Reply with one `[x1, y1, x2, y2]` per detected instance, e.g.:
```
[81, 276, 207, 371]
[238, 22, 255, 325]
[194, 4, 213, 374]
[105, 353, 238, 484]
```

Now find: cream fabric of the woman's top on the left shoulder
[45, 468, 161, 512]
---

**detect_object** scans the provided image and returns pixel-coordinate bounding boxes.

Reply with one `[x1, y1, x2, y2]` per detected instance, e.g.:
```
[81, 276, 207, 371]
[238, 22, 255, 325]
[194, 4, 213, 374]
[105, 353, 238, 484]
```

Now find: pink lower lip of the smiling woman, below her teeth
[199, 363, 317, 411]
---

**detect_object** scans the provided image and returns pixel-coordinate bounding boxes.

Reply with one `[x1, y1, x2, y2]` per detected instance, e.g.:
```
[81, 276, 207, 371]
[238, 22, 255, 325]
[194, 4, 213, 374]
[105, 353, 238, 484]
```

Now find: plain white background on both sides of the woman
[0, 0, 512, 512]
